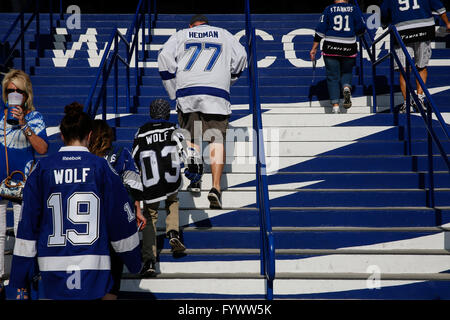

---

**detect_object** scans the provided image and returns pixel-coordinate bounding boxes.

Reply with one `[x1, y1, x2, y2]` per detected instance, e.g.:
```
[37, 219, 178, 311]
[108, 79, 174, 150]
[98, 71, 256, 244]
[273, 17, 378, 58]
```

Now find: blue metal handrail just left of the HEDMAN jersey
[84, 0, 156, 119]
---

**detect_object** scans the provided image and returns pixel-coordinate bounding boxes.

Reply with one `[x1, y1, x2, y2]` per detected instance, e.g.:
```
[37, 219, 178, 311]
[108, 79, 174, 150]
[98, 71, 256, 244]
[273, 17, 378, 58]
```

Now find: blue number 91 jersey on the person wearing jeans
[314, 3, 365, 56]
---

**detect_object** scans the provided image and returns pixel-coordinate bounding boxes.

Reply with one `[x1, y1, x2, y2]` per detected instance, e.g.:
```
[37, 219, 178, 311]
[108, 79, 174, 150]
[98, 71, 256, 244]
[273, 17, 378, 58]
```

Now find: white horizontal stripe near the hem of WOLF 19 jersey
[38, 255, 111, 272]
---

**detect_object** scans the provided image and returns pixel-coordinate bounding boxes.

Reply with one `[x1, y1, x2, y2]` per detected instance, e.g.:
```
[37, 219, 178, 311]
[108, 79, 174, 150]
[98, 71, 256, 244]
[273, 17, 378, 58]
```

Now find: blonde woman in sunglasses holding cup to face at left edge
[0, 69, 48, 296]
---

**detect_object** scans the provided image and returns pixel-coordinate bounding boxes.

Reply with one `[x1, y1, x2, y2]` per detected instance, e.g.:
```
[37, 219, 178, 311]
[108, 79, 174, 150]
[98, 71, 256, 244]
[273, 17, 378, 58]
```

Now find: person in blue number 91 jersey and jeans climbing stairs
[310, 0, 365, 113]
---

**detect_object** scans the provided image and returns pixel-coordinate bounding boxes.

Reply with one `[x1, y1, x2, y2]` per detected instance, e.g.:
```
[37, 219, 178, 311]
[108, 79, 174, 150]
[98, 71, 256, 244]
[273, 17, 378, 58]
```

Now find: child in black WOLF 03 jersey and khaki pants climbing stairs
[132, 99, 203, 277]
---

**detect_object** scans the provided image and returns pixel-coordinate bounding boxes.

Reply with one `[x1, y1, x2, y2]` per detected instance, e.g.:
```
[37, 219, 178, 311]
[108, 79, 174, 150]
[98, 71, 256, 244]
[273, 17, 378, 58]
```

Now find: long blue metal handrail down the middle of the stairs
[245, 0, 275, 300]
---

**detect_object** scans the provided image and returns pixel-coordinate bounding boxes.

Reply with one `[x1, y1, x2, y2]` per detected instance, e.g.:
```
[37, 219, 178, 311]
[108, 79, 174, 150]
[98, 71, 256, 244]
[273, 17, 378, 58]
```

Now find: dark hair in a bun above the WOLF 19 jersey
[59, 102, 92, 144]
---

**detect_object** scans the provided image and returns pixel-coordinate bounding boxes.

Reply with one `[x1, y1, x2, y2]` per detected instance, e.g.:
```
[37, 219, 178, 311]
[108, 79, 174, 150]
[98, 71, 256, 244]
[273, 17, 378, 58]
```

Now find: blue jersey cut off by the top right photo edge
[381, 0, 446, 43]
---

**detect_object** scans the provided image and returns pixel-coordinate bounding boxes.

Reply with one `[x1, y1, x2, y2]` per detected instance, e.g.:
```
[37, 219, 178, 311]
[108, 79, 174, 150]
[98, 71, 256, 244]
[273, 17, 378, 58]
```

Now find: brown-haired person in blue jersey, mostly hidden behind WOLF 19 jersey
[88, 119, 147, 300]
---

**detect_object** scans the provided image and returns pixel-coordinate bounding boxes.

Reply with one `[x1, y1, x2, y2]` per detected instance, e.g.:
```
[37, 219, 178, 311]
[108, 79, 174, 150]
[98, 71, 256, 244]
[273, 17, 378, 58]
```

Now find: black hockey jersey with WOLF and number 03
[132, 120, 181, 203]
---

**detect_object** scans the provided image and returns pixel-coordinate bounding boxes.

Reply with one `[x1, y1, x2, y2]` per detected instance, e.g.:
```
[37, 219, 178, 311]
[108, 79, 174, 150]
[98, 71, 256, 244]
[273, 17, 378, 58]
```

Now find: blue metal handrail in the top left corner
[0, 0, 63, 71]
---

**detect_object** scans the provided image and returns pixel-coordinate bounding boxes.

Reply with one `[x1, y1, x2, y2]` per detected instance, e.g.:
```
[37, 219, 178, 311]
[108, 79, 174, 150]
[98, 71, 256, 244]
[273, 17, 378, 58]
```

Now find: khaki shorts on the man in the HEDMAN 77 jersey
[178, 110, 230, 143]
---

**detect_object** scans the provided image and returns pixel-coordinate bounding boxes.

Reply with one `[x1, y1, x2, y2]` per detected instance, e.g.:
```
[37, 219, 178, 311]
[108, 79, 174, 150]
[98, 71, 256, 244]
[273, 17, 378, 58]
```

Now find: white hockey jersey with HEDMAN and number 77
[158, 24, 247, 115]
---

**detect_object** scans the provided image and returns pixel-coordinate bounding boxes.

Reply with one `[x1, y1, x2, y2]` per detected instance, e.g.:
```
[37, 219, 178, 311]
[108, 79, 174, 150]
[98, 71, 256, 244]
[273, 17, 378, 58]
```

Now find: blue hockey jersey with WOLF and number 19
[10, 147, 141, 300]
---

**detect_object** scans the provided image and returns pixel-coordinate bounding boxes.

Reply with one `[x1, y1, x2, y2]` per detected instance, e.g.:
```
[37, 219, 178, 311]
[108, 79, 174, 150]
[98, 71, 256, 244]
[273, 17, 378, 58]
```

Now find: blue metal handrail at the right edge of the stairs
[362, 21, 450, 208]
